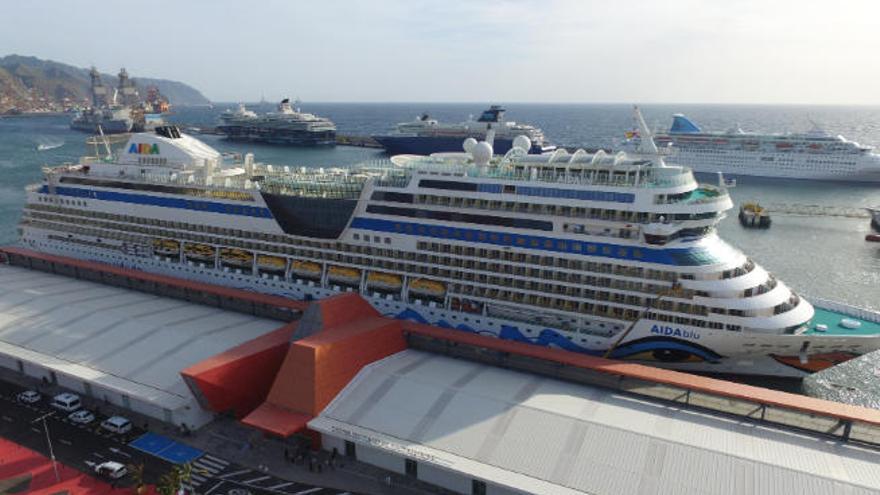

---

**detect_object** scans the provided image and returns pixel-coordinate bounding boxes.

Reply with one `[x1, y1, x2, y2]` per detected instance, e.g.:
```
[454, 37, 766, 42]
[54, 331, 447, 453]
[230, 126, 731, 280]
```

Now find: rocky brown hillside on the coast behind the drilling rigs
[0, 55, 210, 113]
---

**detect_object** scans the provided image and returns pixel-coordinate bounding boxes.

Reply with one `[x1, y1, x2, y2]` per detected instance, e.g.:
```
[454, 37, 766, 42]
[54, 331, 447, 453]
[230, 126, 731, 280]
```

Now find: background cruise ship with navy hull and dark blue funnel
[373, 105, 555, 155]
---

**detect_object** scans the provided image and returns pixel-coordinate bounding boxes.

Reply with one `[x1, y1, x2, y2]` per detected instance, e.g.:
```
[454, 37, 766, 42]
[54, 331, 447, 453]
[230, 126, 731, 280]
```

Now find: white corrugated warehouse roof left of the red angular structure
[0, 265, 281, 410]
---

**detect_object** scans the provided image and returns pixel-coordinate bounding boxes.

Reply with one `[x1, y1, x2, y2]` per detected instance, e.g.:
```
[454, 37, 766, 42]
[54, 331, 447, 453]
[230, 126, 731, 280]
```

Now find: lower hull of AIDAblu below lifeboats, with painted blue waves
[21, 229, 880, 378]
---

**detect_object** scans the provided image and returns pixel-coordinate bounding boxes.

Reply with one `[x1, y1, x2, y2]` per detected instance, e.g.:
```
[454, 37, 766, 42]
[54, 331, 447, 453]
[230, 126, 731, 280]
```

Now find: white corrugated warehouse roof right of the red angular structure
[309, 350, 880, 495]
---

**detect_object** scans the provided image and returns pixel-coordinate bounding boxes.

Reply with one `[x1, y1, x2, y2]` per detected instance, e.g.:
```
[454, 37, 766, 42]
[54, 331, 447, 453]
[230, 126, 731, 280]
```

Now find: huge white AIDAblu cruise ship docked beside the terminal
[20, 120, 880, 376]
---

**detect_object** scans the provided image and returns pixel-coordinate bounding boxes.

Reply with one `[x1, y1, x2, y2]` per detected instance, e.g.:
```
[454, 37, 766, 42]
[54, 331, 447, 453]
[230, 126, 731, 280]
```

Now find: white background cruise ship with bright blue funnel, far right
[636, 114, 880, 182]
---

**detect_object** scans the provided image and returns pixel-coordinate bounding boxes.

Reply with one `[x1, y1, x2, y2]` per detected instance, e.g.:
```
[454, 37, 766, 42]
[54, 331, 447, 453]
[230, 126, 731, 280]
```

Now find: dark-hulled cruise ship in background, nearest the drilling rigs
[217, 98, 336, 146]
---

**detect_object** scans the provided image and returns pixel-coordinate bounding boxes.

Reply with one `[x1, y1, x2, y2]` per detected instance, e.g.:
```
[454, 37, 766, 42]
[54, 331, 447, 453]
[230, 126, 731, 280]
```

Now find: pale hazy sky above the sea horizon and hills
[0, 0, 880, 104]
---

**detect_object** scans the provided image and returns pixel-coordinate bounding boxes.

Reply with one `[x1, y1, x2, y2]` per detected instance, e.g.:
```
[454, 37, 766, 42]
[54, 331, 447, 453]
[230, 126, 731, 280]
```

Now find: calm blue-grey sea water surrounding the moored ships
[0, 103, 880, 310]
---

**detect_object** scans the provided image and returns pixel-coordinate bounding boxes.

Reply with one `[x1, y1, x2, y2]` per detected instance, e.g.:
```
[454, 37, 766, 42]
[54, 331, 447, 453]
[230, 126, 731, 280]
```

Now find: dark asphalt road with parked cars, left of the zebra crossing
[0, 381, 172, 486]
